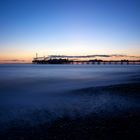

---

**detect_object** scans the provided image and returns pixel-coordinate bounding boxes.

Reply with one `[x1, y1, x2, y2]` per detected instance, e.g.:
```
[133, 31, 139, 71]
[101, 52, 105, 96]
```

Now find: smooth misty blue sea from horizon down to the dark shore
[0, 64, 140, 127]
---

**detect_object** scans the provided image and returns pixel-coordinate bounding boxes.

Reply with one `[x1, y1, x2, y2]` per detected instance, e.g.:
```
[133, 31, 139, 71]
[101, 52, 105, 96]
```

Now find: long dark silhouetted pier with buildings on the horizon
[32, 55, 140, 65]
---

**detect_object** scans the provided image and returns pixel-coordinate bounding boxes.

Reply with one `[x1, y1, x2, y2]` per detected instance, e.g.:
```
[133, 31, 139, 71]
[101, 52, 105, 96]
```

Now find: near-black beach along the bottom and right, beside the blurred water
[0, 83, 140, 140]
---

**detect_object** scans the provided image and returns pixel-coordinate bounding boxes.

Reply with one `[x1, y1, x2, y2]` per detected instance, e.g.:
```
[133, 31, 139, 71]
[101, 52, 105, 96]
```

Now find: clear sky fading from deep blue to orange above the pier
[0, 0, 140, 63]
